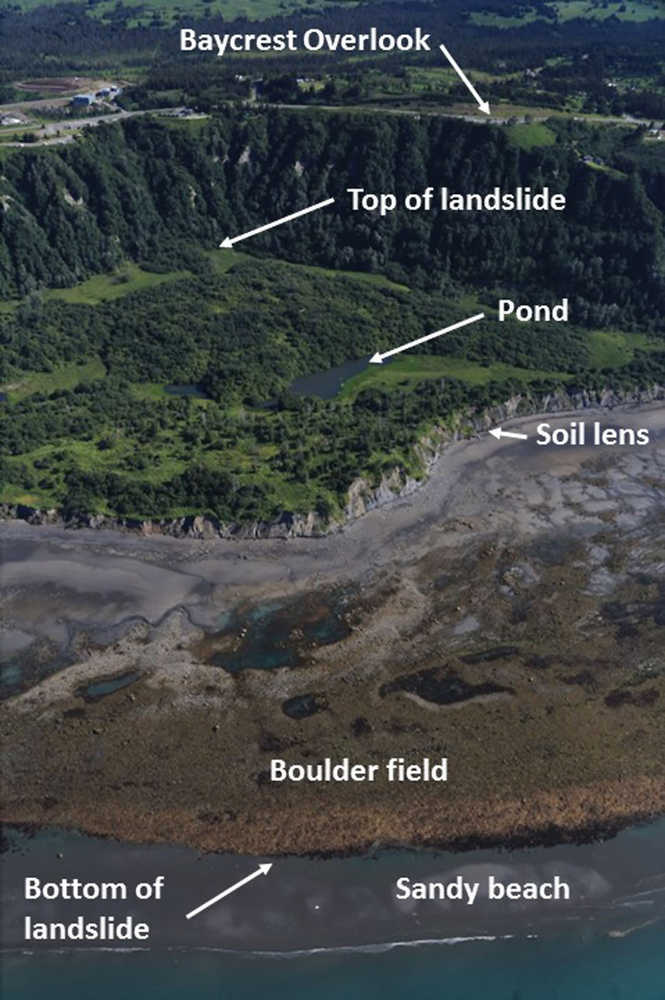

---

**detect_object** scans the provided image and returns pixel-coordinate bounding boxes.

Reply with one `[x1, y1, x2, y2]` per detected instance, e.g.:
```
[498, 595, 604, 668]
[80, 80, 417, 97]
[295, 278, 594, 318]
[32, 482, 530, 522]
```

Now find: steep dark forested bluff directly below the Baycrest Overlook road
[0, 109, 665, 328]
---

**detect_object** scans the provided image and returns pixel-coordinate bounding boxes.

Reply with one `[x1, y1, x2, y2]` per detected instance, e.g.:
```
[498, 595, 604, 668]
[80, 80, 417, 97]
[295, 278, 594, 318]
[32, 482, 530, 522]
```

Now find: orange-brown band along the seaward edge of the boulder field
[0, 778, 665, 860]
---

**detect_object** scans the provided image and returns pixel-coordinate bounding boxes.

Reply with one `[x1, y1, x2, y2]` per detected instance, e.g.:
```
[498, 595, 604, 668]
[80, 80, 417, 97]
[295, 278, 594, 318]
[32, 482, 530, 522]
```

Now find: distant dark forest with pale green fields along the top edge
[5, 0, 665, 76]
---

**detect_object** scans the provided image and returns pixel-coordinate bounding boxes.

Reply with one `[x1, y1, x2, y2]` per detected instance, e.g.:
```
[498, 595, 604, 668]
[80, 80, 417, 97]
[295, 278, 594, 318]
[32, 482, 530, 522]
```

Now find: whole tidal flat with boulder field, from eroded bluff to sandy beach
[0, 408, 665, 854]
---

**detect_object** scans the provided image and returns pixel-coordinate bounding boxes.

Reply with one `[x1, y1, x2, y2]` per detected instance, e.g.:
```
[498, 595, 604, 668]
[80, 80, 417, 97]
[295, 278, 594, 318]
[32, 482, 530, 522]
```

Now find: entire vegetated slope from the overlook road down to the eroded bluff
[0, 109, 665, 522]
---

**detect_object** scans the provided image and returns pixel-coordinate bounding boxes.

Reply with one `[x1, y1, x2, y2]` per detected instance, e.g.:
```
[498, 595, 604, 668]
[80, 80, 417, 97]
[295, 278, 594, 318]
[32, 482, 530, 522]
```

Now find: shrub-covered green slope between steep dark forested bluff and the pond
[0, 252, 612, 405]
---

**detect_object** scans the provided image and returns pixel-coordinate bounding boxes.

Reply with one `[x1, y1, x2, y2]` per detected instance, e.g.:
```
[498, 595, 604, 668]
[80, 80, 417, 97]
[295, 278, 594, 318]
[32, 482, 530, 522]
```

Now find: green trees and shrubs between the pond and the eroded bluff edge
[3, 342, 665, 522]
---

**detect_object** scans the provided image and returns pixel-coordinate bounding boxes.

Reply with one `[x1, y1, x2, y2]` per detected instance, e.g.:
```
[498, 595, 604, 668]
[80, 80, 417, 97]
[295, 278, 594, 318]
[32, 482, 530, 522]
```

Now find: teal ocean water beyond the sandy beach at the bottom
[2, 924, 665, 1000]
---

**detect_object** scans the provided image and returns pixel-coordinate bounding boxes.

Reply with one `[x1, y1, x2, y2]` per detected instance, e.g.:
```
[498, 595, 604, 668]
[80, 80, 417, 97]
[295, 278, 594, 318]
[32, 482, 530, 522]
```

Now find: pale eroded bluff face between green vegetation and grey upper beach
[0, 385, 665, 539]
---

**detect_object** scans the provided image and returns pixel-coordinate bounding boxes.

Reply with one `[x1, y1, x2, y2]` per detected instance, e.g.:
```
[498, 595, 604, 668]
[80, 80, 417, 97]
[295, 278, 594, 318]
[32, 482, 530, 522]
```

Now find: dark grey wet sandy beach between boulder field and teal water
[0, 820, 665, 956]
